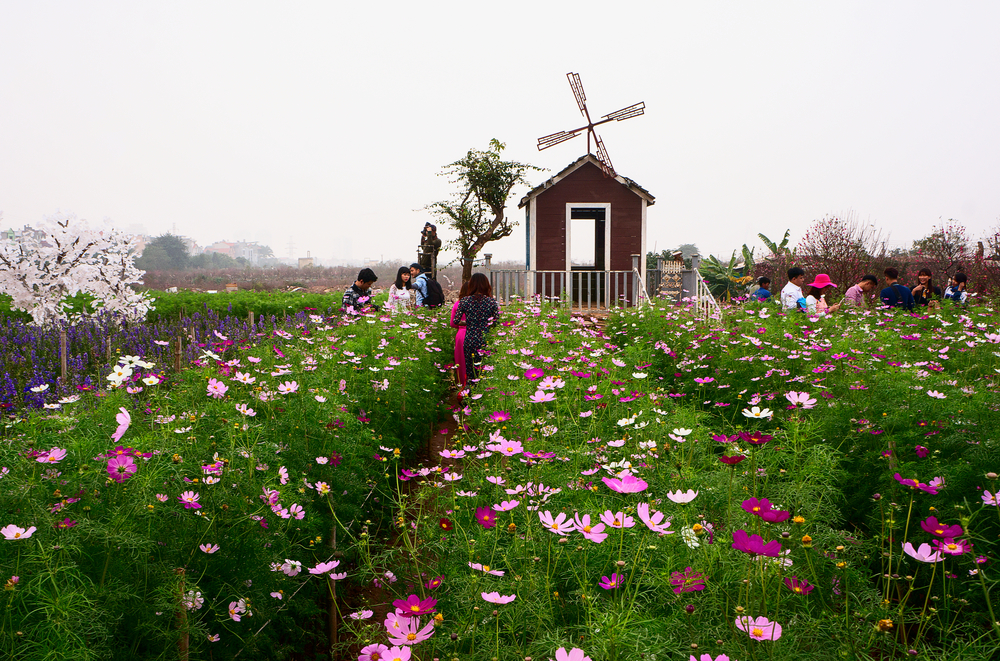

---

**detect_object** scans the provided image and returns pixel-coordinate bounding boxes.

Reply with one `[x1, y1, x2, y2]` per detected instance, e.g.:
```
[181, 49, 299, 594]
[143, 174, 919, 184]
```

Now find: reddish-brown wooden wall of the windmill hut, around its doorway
[532, 163, 643, 271]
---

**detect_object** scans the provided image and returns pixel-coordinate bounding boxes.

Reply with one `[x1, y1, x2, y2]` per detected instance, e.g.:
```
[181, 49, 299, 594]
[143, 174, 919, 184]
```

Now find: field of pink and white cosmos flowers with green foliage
[0, 296, 1000, 661]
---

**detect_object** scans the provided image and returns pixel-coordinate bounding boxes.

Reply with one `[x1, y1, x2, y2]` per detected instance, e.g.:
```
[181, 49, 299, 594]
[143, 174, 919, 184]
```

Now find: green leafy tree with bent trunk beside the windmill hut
[427, 138, 542, 282]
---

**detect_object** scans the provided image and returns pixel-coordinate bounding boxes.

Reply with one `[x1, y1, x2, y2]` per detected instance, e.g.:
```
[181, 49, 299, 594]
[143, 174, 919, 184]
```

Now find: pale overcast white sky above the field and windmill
[0, 0, 1000, 264]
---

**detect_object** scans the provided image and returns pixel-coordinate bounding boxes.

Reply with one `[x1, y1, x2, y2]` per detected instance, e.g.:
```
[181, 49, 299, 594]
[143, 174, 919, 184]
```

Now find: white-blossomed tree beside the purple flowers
[0, 213, 152, 324]
